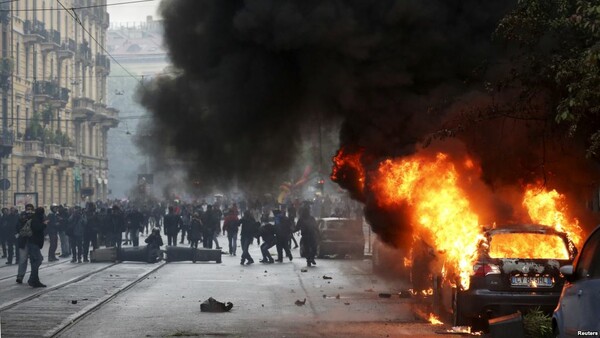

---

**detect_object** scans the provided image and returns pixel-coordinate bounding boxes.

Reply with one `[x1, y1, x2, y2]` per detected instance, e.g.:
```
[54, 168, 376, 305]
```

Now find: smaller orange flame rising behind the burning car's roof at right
[523, 184, 583, 248]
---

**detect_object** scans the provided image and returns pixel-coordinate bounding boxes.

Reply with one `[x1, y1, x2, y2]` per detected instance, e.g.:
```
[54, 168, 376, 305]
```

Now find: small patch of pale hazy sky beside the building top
[107, 0, 160, 24]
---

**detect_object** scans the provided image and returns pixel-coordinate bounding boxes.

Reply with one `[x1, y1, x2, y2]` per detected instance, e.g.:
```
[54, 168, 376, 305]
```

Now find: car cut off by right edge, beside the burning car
[552, 223, 600, 337]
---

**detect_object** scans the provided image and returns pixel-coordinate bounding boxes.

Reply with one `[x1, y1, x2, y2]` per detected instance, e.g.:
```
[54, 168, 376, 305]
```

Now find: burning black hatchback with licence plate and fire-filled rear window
[434, 225, 577, 328]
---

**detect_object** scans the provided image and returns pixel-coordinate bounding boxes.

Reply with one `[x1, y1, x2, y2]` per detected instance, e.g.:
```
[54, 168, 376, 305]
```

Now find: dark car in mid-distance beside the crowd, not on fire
[317, 217, 365, 258]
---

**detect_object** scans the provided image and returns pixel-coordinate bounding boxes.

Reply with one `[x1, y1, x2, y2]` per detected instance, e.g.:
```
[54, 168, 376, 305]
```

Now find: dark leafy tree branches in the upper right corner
[496, 0, 600, 158]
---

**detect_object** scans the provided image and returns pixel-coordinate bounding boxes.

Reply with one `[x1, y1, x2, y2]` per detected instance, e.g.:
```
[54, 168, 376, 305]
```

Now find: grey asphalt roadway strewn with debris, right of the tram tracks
[56, 235, 460, 337]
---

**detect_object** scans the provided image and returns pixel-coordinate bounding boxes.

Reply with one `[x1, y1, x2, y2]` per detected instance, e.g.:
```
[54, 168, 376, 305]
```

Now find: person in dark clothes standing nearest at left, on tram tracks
[21, 207, 47, 288]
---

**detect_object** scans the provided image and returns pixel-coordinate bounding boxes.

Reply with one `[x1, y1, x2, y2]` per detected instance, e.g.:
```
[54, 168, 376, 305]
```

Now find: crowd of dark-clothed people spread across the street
[0, 195, 352, 287]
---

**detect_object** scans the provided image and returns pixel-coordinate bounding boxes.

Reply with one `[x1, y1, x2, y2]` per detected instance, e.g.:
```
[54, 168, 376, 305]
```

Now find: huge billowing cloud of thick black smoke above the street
[140, 0, 600, 247]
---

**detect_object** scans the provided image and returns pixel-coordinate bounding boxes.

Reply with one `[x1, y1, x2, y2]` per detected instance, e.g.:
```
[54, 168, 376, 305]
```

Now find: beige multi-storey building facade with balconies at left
[0, 0, 119, 206]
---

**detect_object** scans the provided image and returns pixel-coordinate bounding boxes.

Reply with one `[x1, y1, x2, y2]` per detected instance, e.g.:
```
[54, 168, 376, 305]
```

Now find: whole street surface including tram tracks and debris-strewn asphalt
[0, 238, 464, 337]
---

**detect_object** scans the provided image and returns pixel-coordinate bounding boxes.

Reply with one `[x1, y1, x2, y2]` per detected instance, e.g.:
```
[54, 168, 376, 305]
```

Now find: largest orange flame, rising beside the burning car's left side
[372, 153, 483, 289]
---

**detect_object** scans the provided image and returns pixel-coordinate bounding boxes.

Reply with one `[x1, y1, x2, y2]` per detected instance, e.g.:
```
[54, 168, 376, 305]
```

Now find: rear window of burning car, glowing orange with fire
[489, 232, 569, 259]
